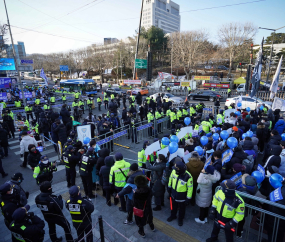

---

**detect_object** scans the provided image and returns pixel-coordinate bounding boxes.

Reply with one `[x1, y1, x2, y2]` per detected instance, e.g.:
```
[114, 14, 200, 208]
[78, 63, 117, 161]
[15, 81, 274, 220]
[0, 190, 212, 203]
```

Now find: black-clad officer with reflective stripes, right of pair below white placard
[79, 147, 96, 198]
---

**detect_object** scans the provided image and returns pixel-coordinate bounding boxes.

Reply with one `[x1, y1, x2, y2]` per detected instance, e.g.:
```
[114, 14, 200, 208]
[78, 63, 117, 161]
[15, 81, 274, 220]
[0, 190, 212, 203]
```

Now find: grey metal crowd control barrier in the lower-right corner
[216, 186, 285, 242]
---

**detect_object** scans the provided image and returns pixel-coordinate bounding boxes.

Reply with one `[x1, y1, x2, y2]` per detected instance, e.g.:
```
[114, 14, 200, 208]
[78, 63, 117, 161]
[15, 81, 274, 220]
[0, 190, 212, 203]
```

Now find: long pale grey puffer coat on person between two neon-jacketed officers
[196, 170, 221, 208]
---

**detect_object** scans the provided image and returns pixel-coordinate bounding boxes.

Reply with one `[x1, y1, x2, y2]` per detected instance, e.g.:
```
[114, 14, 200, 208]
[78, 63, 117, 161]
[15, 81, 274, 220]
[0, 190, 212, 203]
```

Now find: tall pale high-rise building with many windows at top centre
[142, 0, 180, 34]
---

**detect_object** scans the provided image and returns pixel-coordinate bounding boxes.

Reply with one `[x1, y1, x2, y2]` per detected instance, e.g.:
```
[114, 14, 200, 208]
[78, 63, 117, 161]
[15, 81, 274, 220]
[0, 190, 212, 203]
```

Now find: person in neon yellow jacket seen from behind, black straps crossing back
[109, 153, 131, 212]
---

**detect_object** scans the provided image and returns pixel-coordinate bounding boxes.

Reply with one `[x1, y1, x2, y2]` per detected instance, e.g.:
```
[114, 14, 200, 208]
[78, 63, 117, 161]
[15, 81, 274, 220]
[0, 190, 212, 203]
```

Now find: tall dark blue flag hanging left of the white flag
[250, 38, 264, 97]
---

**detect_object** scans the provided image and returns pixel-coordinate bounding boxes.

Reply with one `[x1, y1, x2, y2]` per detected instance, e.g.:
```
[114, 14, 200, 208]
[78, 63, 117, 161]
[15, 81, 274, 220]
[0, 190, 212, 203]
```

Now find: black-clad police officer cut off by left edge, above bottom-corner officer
[0, 183, 20, 242]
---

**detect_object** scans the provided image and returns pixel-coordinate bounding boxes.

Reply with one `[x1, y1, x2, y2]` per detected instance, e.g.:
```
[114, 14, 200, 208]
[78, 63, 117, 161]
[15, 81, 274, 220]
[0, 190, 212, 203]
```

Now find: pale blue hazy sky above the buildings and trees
[0, 0, 285, 54]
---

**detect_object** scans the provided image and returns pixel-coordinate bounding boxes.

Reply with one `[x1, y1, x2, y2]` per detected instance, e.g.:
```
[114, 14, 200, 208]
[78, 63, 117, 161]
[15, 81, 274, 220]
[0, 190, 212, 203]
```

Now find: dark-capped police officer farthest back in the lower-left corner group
[6, 172, 29, 206]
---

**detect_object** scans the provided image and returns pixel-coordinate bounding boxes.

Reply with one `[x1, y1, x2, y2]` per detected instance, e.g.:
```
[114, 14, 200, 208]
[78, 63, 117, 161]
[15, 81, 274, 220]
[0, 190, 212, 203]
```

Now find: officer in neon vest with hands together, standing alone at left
[33, 156, 57, 185]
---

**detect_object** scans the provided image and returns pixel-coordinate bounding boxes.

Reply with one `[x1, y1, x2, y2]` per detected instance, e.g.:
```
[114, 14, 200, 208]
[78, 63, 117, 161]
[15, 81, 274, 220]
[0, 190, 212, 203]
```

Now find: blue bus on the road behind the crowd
[59, 79, 97, 96]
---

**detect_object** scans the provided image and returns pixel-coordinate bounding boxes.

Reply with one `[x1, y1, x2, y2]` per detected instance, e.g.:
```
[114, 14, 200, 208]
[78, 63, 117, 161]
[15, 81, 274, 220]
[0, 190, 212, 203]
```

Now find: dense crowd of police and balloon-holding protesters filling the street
[0, 83, 285, 242]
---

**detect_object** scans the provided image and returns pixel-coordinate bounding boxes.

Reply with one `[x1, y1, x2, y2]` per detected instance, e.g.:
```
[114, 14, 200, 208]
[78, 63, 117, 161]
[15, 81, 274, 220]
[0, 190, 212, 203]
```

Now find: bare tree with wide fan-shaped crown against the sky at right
[218, 23, 257, 74]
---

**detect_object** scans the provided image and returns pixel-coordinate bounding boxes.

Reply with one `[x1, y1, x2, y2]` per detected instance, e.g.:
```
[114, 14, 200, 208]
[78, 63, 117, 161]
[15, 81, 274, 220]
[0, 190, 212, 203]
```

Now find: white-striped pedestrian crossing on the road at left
[8, 132, 65, 172]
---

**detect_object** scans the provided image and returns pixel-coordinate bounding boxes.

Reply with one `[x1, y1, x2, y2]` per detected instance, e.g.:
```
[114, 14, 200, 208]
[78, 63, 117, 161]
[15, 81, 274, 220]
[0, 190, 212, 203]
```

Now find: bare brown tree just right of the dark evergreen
[169, 30, 208, 80]
